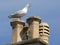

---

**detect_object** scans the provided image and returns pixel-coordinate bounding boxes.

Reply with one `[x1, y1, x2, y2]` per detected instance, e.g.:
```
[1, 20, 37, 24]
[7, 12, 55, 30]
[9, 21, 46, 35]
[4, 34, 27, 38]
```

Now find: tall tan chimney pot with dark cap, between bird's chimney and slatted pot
[26, 16, 41, 39]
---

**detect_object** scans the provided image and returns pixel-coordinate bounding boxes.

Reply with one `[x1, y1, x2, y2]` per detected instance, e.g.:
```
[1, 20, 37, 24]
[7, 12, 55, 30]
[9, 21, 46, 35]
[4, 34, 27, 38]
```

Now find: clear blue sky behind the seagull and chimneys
[0, 0, 60, 45]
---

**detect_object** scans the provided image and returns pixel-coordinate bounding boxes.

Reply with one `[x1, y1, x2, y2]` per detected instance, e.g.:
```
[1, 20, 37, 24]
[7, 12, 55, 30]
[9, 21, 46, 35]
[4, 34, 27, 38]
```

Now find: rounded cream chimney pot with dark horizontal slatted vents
[39, 22, 50, 43]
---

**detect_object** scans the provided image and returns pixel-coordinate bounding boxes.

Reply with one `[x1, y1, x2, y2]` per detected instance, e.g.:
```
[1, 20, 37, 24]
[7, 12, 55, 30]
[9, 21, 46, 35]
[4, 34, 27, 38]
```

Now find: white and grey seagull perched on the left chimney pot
[8, 3, 30, 18]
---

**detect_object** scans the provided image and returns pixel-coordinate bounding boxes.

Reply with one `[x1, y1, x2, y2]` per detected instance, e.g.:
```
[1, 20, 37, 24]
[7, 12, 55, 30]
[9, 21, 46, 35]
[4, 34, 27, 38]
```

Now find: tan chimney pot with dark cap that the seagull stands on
[10, 19, 25, 43]
